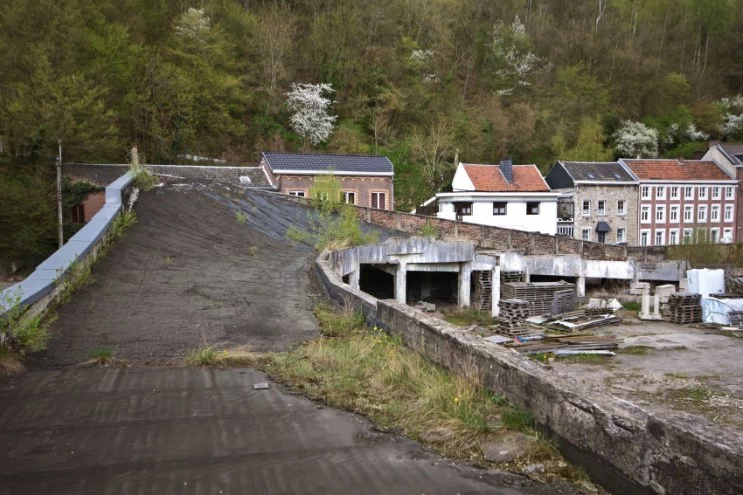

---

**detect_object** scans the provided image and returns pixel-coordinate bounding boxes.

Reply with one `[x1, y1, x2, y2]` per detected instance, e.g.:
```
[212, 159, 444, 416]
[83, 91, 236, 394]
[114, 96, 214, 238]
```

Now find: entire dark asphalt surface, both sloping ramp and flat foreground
[0, 184, 575, 494]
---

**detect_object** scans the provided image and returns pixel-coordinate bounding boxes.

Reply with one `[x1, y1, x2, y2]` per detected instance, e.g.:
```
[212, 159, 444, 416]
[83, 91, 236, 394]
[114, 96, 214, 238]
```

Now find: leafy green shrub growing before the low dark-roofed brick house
[286, 175, 379, 251]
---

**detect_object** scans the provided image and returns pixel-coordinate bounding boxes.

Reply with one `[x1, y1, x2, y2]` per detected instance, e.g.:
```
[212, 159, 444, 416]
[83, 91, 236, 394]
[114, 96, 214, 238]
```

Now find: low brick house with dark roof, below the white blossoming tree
[260, 151, 395, 210]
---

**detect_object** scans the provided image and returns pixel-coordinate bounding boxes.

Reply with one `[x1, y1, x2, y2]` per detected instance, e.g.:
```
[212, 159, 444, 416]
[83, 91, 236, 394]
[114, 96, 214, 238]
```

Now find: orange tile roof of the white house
[462, 163, 550, 192]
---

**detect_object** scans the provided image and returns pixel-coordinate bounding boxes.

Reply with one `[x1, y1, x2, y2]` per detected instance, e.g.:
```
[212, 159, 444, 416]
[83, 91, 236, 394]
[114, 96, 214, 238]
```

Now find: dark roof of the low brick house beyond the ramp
[263, 151, 394, 175]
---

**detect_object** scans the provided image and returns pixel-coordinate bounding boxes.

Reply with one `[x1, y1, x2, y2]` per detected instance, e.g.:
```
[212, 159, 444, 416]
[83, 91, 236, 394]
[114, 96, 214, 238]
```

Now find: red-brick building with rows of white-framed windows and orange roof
[620, 159, 738, 246]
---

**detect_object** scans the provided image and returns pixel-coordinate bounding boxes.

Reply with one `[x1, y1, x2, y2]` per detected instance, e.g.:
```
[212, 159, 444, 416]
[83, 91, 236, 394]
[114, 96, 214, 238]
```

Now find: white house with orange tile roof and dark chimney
[436, 160, 559, 234]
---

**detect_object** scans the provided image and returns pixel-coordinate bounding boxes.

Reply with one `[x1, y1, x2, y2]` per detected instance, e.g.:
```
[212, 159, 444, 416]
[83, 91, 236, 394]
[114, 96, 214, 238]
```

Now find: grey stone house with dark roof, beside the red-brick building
[545, 161, 637, 245]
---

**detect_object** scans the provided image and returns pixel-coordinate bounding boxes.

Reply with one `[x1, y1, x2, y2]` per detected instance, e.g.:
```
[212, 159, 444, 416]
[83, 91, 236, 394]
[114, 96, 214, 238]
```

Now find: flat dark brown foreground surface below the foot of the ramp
[0, 368, 564, 495]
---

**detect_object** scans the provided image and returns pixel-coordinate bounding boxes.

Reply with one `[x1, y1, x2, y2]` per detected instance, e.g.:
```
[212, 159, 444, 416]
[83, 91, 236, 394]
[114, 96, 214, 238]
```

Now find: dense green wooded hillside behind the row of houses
[0, 0, 743, 211]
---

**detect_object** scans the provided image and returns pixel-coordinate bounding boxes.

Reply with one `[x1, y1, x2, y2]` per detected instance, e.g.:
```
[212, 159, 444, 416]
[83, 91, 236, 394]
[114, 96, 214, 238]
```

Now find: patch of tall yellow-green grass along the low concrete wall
[256, 305, 586, 480]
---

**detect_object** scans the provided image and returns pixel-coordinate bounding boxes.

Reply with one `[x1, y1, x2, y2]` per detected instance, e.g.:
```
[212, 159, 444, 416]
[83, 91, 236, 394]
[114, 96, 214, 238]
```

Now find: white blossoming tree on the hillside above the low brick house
[286, 83, 337, 146]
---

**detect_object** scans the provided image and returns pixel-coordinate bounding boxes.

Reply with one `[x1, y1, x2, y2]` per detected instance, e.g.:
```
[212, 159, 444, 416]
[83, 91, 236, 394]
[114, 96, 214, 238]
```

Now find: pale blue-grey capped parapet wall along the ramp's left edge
[0, 174, 132, 317]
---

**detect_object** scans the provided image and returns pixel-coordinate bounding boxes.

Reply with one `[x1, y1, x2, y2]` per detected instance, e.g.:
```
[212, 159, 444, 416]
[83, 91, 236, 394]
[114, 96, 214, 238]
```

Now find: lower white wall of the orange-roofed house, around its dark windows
[436, 193, 557, 235]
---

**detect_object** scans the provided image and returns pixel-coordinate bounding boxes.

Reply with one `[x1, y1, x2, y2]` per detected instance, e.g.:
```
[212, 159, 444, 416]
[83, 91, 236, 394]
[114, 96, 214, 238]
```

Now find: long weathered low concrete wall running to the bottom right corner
[316, 254, 743, 495]
